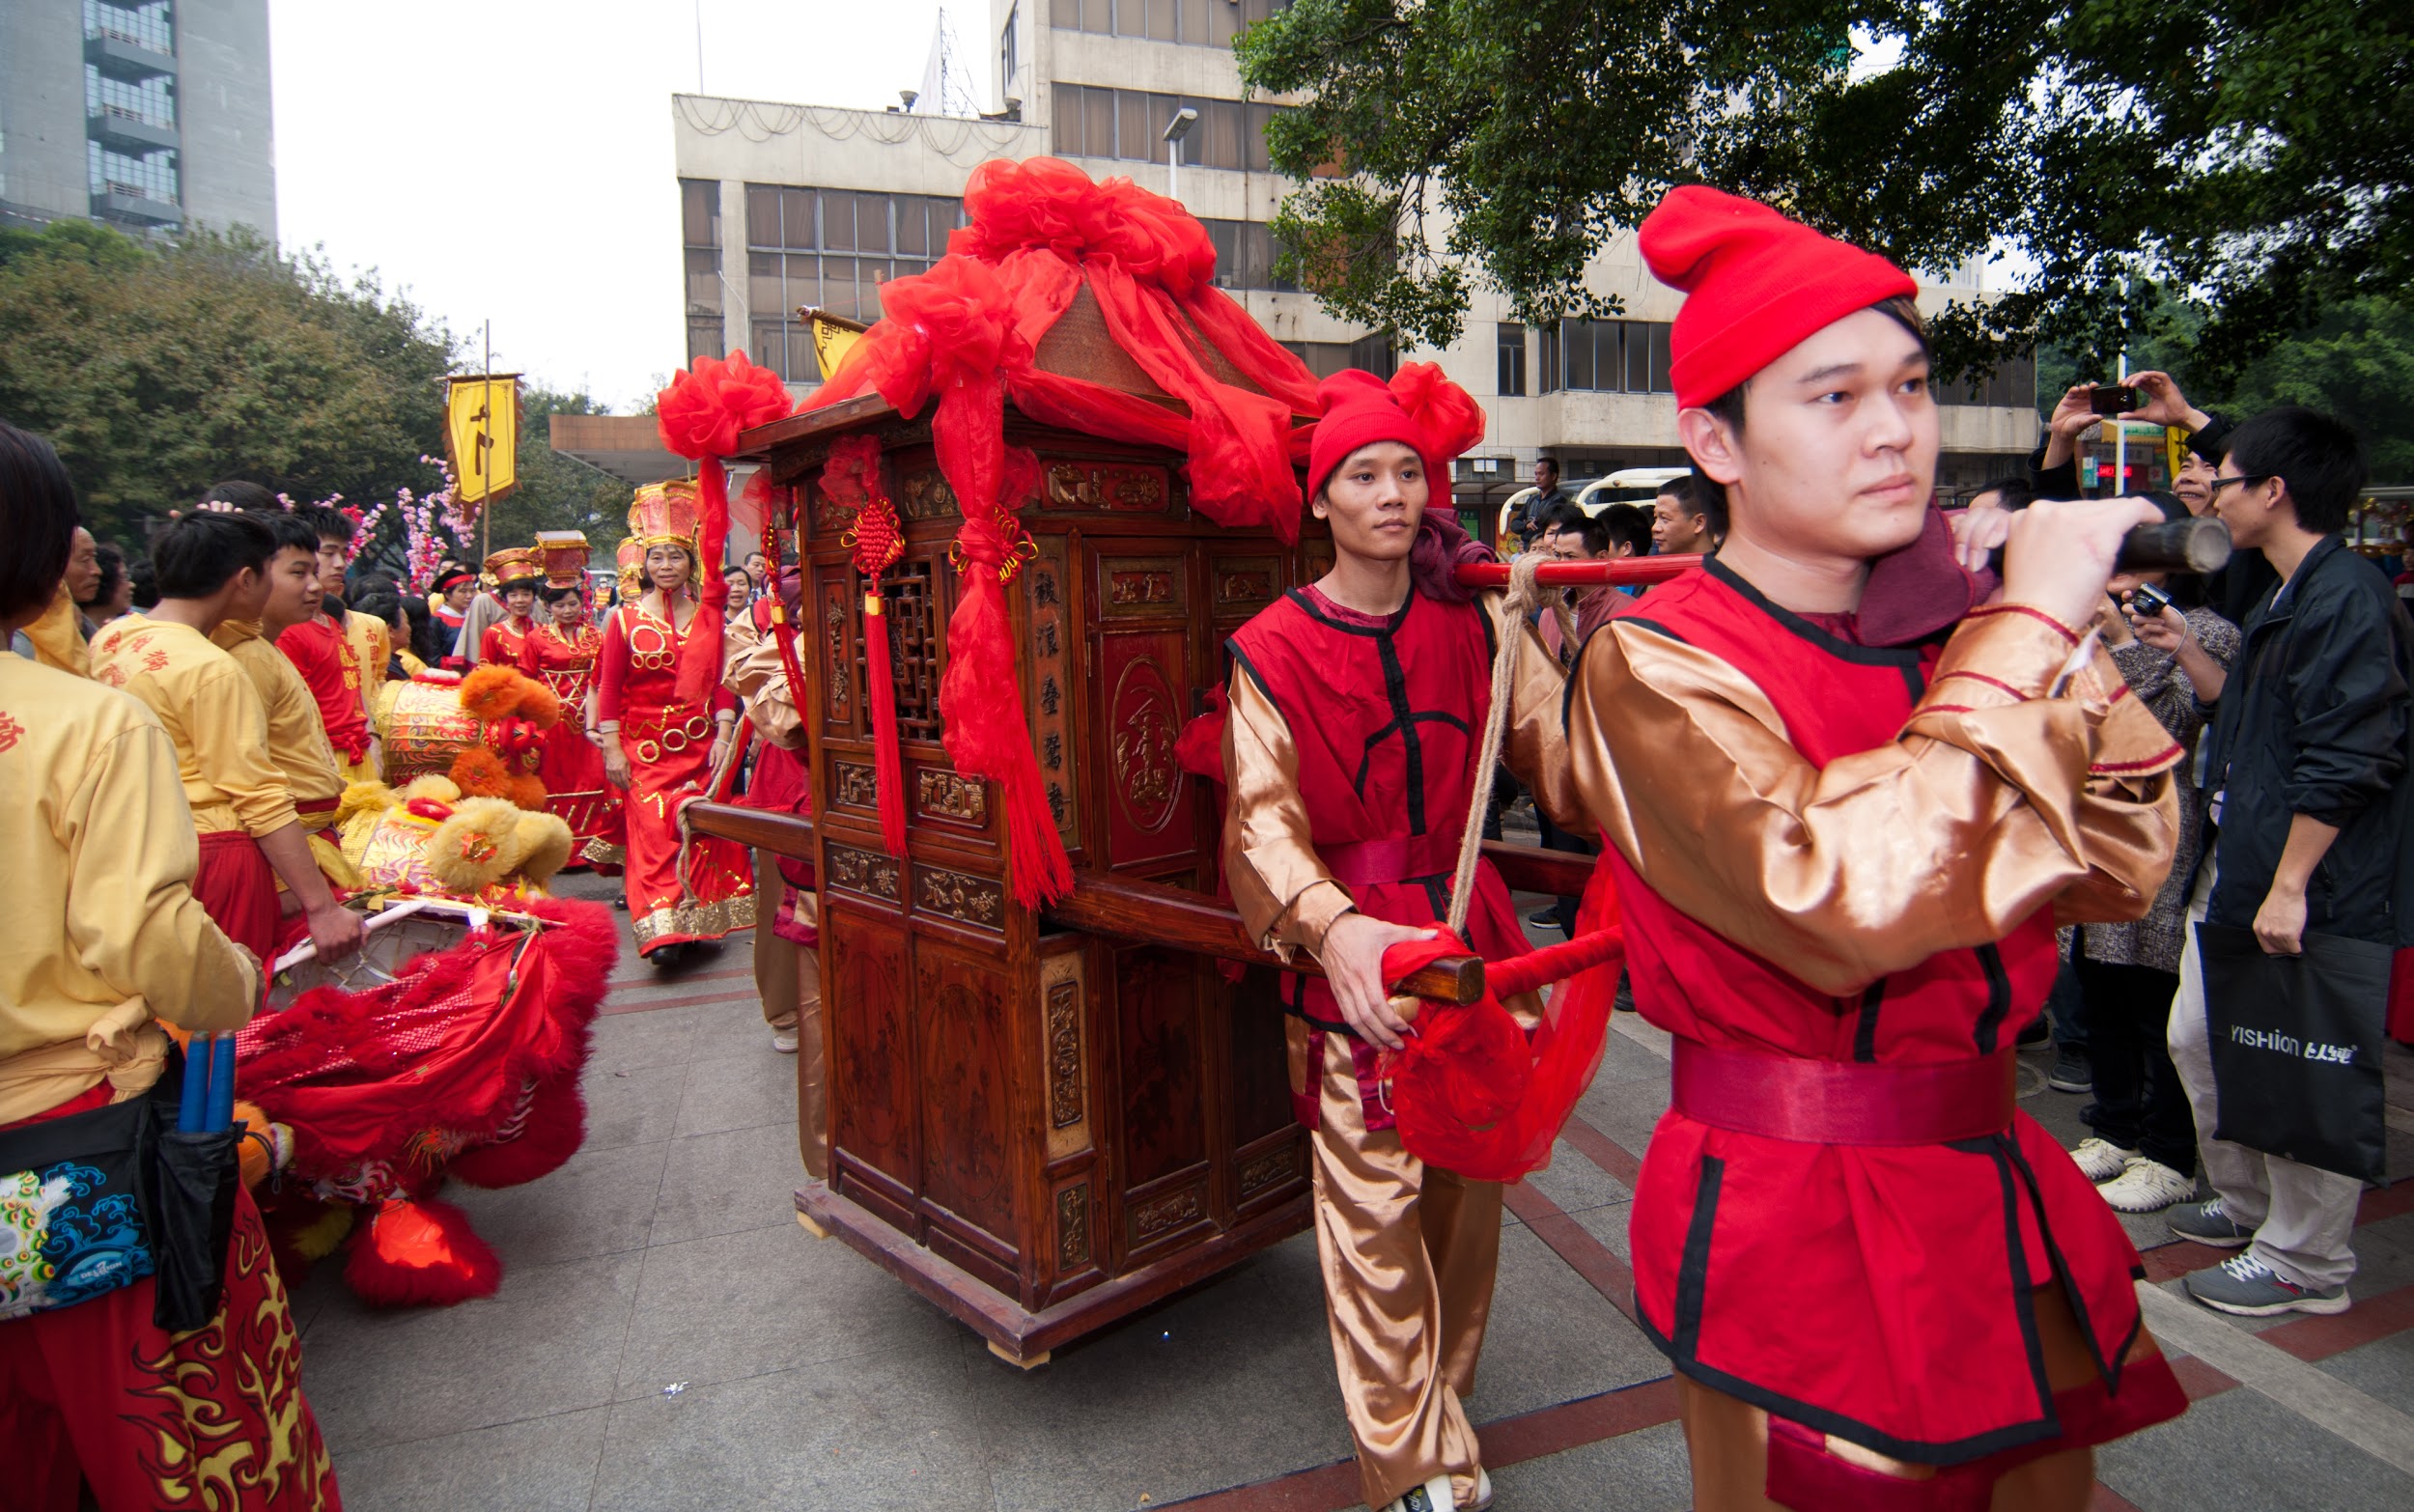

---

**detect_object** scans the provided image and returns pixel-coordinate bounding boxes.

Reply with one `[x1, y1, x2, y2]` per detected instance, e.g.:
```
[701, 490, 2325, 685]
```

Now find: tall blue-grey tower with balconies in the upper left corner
[0, 0, 278, 239]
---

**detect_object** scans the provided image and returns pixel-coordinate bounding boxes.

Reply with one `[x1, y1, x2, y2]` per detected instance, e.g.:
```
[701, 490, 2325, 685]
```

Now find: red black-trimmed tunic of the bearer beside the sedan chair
[1226, 587, 1529, 1131]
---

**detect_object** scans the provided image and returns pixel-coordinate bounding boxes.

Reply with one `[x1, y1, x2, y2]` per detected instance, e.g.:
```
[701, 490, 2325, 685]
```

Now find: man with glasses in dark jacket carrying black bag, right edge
[2139, 406, 2414, 1316]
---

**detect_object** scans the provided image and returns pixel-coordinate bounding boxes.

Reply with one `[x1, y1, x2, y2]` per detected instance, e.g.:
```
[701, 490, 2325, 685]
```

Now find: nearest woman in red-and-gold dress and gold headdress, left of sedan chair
[597, 481, 753, 966]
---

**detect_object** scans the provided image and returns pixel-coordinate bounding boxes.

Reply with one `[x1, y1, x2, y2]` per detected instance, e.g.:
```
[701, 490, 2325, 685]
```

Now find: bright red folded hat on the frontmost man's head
[1640, 183, 1920, 408]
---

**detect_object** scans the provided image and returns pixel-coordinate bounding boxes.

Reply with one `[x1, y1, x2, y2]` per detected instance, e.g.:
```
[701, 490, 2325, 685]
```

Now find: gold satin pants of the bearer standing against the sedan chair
[1289, 1020, 1502, 1507]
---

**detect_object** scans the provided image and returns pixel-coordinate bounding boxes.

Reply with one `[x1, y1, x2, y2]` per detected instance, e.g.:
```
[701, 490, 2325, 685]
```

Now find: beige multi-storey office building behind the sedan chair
[671, 0, 2037, 515]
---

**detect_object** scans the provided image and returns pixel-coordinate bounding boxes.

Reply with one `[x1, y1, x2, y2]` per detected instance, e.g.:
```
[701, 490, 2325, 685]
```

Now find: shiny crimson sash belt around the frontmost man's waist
[1670, 1039, 2016, 1145]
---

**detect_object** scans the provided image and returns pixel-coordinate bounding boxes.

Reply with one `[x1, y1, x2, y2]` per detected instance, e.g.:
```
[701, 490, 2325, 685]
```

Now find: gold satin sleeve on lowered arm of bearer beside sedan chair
[1224, 666, 1352, 962]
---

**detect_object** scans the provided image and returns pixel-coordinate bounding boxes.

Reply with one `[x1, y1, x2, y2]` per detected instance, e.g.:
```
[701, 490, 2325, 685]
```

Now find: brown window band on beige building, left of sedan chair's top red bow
[746, 183, 964, 384]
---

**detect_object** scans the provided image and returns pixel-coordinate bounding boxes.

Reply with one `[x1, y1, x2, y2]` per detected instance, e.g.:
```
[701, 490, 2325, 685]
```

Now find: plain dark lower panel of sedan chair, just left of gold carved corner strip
[915, 938, 1014, 1248]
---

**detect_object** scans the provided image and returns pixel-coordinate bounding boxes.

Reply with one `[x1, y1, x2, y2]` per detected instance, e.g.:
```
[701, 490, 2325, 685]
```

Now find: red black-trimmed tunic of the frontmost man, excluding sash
[1606, 563, 2168, 1464]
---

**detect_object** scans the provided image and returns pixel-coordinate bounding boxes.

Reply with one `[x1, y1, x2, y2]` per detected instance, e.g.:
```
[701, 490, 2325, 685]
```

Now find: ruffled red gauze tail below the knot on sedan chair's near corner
[940, 563, 1072, 893]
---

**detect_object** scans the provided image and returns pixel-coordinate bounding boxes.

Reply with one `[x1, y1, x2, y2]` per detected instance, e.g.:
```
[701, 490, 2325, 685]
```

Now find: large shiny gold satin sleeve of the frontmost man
[1567, 608, 2182, 995]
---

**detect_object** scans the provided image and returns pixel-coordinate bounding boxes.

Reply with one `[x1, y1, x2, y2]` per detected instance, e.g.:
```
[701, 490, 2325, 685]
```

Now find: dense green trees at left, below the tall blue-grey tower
[0, 220, 454, 544]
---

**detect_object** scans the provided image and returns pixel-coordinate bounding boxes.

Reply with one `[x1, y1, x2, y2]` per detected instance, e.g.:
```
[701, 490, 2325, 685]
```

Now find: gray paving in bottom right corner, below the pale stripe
[2095, 1388, 2414, 1512]
